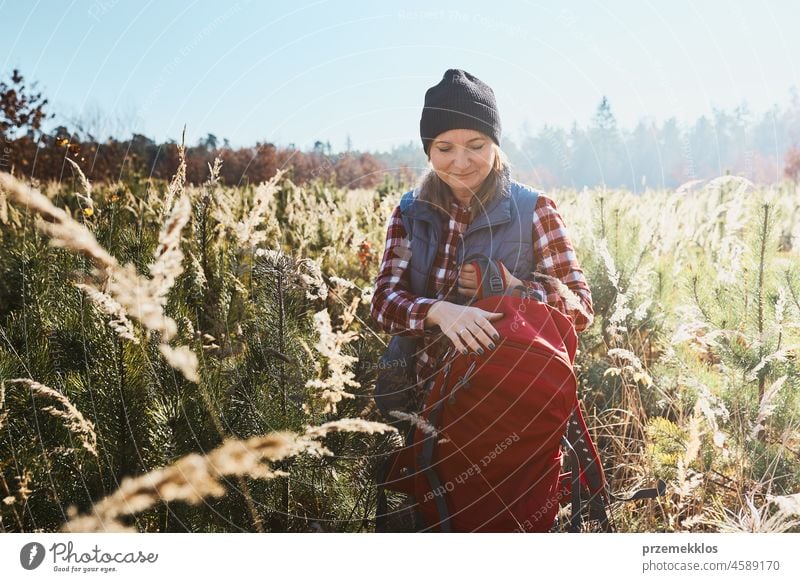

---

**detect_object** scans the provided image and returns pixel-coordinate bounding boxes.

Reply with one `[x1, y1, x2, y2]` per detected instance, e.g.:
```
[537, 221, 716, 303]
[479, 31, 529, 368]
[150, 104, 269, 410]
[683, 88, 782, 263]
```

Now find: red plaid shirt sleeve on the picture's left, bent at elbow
[370, 206, 438, 336]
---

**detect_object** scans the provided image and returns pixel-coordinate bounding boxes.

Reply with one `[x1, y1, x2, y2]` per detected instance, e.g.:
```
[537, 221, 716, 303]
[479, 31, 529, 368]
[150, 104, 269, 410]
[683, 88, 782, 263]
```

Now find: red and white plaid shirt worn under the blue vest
[371, 194, 594, 386]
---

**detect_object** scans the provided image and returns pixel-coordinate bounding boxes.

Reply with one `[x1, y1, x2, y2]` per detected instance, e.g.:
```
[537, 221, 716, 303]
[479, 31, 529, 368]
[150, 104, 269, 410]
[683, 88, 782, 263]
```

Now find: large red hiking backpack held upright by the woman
[377, 256, 610, 532]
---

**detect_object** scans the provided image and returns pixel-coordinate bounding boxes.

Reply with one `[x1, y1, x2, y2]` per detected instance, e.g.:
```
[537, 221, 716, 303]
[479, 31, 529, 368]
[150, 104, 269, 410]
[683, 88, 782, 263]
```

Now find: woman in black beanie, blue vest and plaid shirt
[371, 69, 593, 410]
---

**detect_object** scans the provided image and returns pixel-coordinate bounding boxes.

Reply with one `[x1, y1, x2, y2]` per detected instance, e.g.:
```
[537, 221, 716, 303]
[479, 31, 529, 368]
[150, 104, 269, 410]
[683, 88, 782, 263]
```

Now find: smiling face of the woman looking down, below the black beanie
[430, 129, 496, 202]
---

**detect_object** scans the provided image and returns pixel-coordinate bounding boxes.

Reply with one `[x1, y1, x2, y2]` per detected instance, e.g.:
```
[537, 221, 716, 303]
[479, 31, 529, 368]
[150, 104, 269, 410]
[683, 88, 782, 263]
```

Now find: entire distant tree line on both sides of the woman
[0, 70, 800, 192]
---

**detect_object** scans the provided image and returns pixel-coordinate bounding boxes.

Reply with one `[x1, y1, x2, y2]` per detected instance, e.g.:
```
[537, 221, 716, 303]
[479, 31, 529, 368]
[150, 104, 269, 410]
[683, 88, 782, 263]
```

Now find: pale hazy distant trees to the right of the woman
[504, 92, 800, 191]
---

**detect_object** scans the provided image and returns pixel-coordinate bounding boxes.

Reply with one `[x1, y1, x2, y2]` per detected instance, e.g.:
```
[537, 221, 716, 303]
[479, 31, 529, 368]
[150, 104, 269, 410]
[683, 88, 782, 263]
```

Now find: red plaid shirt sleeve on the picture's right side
[522, 194, 594, 332]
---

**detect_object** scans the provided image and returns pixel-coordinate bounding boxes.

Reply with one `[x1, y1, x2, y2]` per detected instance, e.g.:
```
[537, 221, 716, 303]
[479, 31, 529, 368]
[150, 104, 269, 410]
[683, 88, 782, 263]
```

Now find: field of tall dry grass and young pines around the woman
[0, 153, 800, 532]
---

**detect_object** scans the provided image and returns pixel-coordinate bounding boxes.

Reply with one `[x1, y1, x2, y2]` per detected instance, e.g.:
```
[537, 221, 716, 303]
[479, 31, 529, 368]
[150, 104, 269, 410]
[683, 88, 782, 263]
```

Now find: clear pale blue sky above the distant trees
[0, 0, 800, 150]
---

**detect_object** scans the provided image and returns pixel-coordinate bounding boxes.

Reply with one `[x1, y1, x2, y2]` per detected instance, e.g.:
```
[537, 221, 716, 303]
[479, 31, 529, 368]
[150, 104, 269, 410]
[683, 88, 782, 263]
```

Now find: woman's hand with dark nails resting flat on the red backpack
[425, 301, 504, 354]
